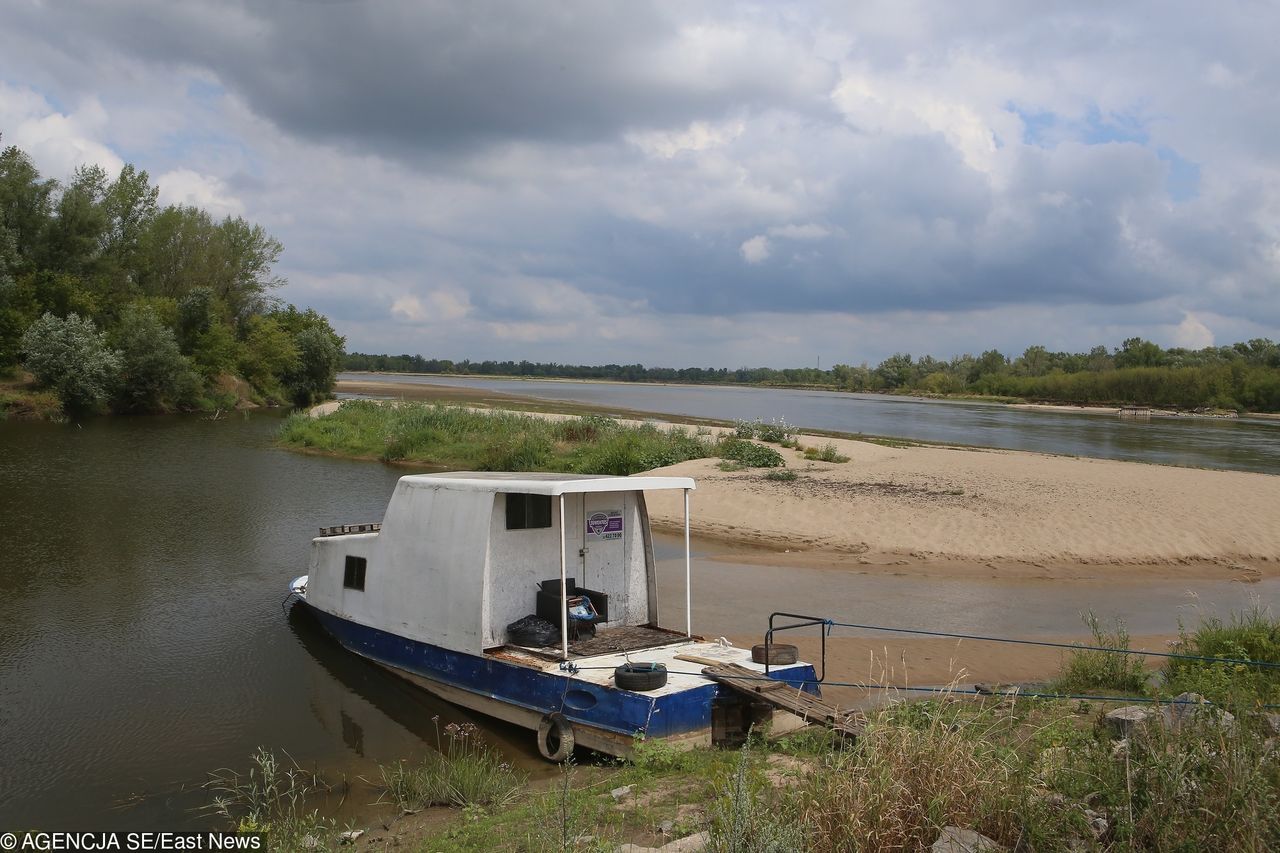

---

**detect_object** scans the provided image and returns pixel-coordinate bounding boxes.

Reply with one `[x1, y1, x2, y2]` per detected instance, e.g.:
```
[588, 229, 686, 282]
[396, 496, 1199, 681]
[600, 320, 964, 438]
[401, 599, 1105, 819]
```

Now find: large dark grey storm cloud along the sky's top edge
[12, 0, 836, 156]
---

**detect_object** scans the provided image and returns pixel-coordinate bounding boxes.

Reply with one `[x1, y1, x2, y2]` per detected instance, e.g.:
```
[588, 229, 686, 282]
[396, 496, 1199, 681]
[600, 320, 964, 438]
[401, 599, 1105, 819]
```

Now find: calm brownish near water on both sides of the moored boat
[0, 414, 1277, 829]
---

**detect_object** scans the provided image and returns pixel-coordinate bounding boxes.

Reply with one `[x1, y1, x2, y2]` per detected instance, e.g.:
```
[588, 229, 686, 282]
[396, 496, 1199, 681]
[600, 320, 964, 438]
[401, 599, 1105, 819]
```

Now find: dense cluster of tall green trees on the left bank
[0, 140, 343, 412]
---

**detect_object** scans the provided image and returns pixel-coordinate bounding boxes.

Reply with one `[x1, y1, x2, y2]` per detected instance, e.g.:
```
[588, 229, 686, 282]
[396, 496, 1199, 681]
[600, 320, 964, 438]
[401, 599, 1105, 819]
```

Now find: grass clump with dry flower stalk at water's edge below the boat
[381, 722, 527, 809]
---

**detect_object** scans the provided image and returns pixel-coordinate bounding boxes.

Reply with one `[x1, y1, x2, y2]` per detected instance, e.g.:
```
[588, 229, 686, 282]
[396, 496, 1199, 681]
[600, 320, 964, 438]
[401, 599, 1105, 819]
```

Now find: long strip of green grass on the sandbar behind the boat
[278, 401, 782, 476]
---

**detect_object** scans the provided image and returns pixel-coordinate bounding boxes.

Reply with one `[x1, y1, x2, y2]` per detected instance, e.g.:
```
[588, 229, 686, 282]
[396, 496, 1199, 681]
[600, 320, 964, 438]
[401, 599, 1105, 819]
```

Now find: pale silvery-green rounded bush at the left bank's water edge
[22, 314, 120, 411]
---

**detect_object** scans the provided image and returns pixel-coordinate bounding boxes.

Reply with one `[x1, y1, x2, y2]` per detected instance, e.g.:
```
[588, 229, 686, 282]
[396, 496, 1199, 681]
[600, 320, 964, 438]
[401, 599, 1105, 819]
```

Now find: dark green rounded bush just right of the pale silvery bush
[114, 305, 200, 411]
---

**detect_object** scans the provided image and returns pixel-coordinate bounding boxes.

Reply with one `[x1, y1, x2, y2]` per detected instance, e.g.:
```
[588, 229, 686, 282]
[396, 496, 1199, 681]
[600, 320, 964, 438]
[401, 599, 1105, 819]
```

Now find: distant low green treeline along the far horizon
[343, 338, 1280, 412]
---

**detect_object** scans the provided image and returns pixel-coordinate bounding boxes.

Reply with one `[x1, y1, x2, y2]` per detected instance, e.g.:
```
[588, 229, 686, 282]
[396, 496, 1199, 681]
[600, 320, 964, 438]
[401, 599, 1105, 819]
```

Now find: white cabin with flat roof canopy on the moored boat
[306, 473, 694, 658]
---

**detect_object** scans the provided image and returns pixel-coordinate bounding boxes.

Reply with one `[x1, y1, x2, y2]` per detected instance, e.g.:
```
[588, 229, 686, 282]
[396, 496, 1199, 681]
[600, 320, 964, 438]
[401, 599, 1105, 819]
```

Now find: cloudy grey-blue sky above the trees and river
[0, 0, 1280, 368]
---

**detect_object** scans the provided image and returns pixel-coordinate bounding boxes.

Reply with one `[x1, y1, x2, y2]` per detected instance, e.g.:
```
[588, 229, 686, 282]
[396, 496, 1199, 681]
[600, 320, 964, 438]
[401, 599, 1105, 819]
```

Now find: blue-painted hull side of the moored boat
[301, 599, 818, 752]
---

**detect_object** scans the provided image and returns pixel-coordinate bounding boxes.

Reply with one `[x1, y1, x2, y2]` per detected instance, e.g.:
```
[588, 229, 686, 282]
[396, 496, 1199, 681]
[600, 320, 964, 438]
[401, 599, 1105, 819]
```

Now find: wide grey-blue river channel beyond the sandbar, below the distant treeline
[340, 373, 1280, 474]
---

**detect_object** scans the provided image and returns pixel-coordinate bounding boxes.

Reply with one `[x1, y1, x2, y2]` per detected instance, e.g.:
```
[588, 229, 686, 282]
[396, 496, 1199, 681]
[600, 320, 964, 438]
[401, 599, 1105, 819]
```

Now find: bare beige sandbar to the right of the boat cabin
[649, 437, 1280, 579]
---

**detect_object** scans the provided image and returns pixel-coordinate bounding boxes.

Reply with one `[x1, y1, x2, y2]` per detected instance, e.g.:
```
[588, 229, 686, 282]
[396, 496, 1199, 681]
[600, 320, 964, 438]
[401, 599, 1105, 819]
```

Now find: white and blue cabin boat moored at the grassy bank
[289, 473, 817, 761]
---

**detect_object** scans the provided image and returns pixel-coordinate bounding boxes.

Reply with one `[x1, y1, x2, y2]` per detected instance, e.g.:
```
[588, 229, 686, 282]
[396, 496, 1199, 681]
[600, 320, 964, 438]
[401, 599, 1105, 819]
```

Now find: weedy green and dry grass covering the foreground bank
[223, 676, 1280, 853]
